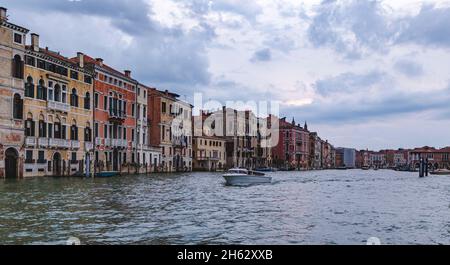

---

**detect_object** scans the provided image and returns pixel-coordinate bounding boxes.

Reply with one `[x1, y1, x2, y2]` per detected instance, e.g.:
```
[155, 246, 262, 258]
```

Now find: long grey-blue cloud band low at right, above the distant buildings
[283, 74, 450, 124]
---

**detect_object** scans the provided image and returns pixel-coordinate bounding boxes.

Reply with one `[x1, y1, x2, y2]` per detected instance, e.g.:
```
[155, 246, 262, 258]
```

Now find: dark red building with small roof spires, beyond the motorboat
[272, 118, 310, 169]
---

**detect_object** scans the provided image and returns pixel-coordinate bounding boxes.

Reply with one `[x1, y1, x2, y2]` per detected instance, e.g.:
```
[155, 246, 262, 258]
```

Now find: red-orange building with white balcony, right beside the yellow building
[72, 55, 137, 172]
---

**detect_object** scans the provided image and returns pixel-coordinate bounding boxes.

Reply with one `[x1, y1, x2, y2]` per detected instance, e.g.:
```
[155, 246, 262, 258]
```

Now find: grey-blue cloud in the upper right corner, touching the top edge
[308, 0, 450, 59]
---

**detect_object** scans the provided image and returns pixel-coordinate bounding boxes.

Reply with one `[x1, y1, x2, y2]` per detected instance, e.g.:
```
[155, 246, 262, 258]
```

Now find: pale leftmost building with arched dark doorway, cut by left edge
[0, 7, 29, 178]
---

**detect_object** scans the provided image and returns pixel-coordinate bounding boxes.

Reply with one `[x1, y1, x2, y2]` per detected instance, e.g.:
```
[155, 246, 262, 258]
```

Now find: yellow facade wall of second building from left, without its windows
[24, 49, 93, 177]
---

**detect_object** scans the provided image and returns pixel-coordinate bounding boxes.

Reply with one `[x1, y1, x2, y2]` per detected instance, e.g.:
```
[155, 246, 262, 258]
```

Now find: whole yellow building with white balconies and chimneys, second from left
[23, 34, 94, 177]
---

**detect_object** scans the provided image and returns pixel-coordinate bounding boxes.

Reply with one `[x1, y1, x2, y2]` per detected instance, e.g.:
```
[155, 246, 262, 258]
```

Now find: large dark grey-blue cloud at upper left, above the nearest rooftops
[5, 0, 215, 88]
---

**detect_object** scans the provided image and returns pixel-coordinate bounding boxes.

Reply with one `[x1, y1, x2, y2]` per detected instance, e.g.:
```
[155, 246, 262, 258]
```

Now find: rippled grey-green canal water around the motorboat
[0, 170, 450, 245]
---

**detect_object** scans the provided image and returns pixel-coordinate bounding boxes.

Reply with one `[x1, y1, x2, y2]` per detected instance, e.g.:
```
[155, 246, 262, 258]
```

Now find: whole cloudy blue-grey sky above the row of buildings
[2, 0, 450, 149]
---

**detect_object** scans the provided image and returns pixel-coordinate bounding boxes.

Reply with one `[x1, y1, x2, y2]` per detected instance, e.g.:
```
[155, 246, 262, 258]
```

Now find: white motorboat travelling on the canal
[223, 168, 272, 186]
